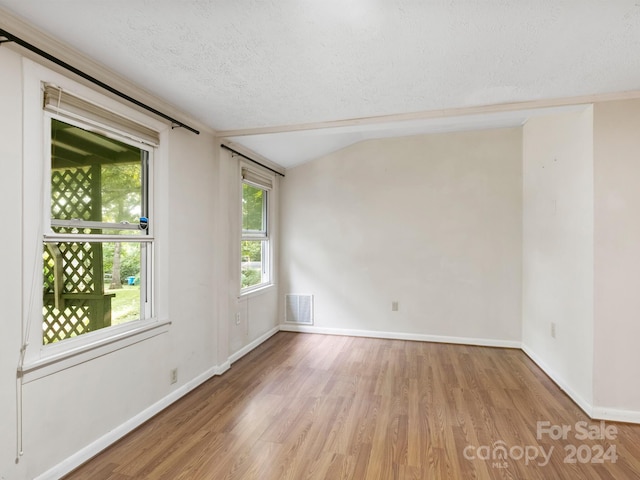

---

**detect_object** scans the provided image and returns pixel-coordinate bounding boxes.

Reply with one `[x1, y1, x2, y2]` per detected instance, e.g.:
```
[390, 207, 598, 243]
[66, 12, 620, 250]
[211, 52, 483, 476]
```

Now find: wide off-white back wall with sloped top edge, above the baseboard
[280, 128, 522, 345]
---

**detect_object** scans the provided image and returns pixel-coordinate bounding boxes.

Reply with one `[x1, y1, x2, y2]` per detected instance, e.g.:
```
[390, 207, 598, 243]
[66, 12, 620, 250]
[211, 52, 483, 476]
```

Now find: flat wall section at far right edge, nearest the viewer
[594, 100, 640, 423]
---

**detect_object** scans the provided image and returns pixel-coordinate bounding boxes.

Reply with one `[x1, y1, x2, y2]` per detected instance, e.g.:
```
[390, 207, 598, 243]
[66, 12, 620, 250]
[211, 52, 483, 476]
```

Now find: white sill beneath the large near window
[19, 320, 171, 384]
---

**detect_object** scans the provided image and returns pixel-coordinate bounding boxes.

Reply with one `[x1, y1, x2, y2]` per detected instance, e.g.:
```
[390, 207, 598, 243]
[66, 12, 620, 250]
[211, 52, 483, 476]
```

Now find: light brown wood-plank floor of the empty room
[66, 332, 640, 480]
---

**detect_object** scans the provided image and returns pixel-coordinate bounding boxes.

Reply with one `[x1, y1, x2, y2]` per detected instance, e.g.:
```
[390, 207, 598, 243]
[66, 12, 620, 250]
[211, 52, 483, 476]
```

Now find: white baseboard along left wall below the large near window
[35, 361, 230, 480]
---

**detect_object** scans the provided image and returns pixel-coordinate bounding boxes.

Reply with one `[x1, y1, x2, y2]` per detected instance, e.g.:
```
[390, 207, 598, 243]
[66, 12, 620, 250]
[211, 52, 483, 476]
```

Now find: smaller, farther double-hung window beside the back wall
[241, 167, 273, 292]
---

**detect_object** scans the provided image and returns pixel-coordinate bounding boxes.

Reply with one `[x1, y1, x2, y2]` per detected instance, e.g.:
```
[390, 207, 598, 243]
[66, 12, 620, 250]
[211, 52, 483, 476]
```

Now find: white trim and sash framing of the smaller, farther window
[238, 161, 276, 298]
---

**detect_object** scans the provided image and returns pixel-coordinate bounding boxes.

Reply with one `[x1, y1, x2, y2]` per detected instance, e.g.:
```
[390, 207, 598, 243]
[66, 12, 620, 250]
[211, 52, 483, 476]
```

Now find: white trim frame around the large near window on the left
[19, 58, 170, 382]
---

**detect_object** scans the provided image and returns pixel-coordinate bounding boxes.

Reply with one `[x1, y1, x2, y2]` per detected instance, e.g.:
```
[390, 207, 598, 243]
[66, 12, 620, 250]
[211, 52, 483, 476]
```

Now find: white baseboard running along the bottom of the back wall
[280, 323, 522, 348]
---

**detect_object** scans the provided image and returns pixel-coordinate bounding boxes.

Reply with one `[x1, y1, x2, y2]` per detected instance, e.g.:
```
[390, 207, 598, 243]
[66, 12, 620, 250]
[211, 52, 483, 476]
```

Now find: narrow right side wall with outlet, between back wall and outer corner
[522, 108, 594, 411]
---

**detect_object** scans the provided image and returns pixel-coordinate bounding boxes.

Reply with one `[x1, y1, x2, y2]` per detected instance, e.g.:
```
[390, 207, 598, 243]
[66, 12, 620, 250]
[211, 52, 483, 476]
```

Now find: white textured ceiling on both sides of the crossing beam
[0, 0, 640, 166]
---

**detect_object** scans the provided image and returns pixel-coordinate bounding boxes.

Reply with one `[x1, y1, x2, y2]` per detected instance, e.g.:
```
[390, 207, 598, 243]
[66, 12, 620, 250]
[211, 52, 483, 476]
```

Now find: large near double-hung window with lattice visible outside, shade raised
[42, 85, 158, 344]
